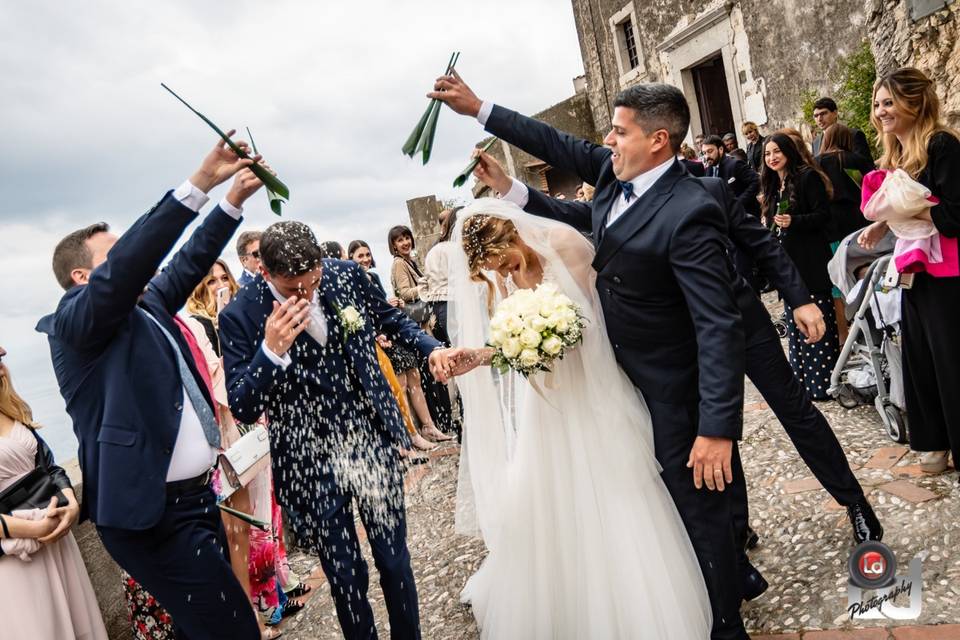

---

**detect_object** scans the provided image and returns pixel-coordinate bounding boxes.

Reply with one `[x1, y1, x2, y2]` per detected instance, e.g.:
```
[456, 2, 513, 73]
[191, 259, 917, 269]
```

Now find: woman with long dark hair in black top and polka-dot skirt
[760, 132, 839, 400]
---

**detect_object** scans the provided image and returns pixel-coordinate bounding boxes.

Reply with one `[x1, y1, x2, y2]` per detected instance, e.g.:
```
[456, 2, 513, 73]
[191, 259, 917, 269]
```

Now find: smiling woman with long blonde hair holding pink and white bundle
[860, 68, 960, 472]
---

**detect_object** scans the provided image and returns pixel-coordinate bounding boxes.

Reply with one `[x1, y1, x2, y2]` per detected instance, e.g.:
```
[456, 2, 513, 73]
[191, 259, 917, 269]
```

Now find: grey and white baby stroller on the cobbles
[828, 231, 907, 443]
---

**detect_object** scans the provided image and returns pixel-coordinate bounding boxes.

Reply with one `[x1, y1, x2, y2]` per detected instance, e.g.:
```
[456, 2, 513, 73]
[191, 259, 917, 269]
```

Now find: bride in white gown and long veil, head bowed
[449, 198, 711, 640]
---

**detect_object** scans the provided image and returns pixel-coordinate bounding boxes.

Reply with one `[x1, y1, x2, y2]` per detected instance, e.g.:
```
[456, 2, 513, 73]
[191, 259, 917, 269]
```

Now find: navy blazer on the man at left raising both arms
[37, 193, 240, 529]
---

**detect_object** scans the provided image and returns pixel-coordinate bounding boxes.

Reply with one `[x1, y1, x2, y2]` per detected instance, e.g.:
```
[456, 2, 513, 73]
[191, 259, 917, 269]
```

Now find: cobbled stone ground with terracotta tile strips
[274, 302, 960, 640]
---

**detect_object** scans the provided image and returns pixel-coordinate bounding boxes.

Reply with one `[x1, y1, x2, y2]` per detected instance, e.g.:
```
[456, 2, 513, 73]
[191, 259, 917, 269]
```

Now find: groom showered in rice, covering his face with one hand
[220, 221, 449, 639]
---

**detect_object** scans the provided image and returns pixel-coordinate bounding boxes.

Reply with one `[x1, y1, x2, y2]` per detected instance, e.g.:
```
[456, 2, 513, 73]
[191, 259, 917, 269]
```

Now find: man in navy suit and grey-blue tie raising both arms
[37, 132, 261, 639]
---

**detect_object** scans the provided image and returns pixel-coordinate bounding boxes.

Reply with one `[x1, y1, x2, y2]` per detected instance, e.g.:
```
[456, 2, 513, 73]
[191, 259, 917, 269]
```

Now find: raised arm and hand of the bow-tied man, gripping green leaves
[428, 71, 611, 184]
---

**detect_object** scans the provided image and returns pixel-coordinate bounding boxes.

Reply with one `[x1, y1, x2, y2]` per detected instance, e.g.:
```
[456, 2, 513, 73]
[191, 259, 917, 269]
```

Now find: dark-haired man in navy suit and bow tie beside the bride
[429, 73, 747, 638]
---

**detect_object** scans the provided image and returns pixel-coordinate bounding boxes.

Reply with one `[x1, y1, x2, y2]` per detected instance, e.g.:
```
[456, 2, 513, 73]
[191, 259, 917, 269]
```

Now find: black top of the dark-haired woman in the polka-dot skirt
[767, 168, 833, 294]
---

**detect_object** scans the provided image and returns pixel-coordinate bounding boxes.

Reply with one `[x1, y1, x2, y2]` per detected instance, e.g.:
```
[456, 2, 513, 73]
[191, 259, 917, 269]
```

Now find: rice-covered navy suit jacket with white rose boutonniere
[220, 260, 442, 492]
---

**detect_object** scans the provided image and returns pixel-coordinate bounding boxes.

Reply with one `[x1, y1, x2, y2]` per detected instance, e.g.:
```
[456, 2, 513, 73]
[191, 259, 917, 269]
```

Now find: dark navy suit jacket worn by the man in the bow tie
[485, 105, 744, 438]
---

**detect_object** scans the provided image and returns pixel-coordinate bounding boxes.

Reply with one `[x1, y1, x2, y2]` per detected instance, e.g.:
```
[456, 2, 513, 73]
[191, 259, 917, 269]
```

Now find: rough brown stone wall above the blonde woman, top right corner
[869, 0, 960, 127]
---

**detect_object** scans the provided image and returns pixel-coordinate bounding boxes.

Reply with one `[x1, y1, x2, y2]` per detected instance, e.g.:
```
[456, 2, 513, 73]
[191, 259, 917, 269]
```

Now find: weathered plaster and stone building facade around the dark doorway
[572, 0, 876, 143]
